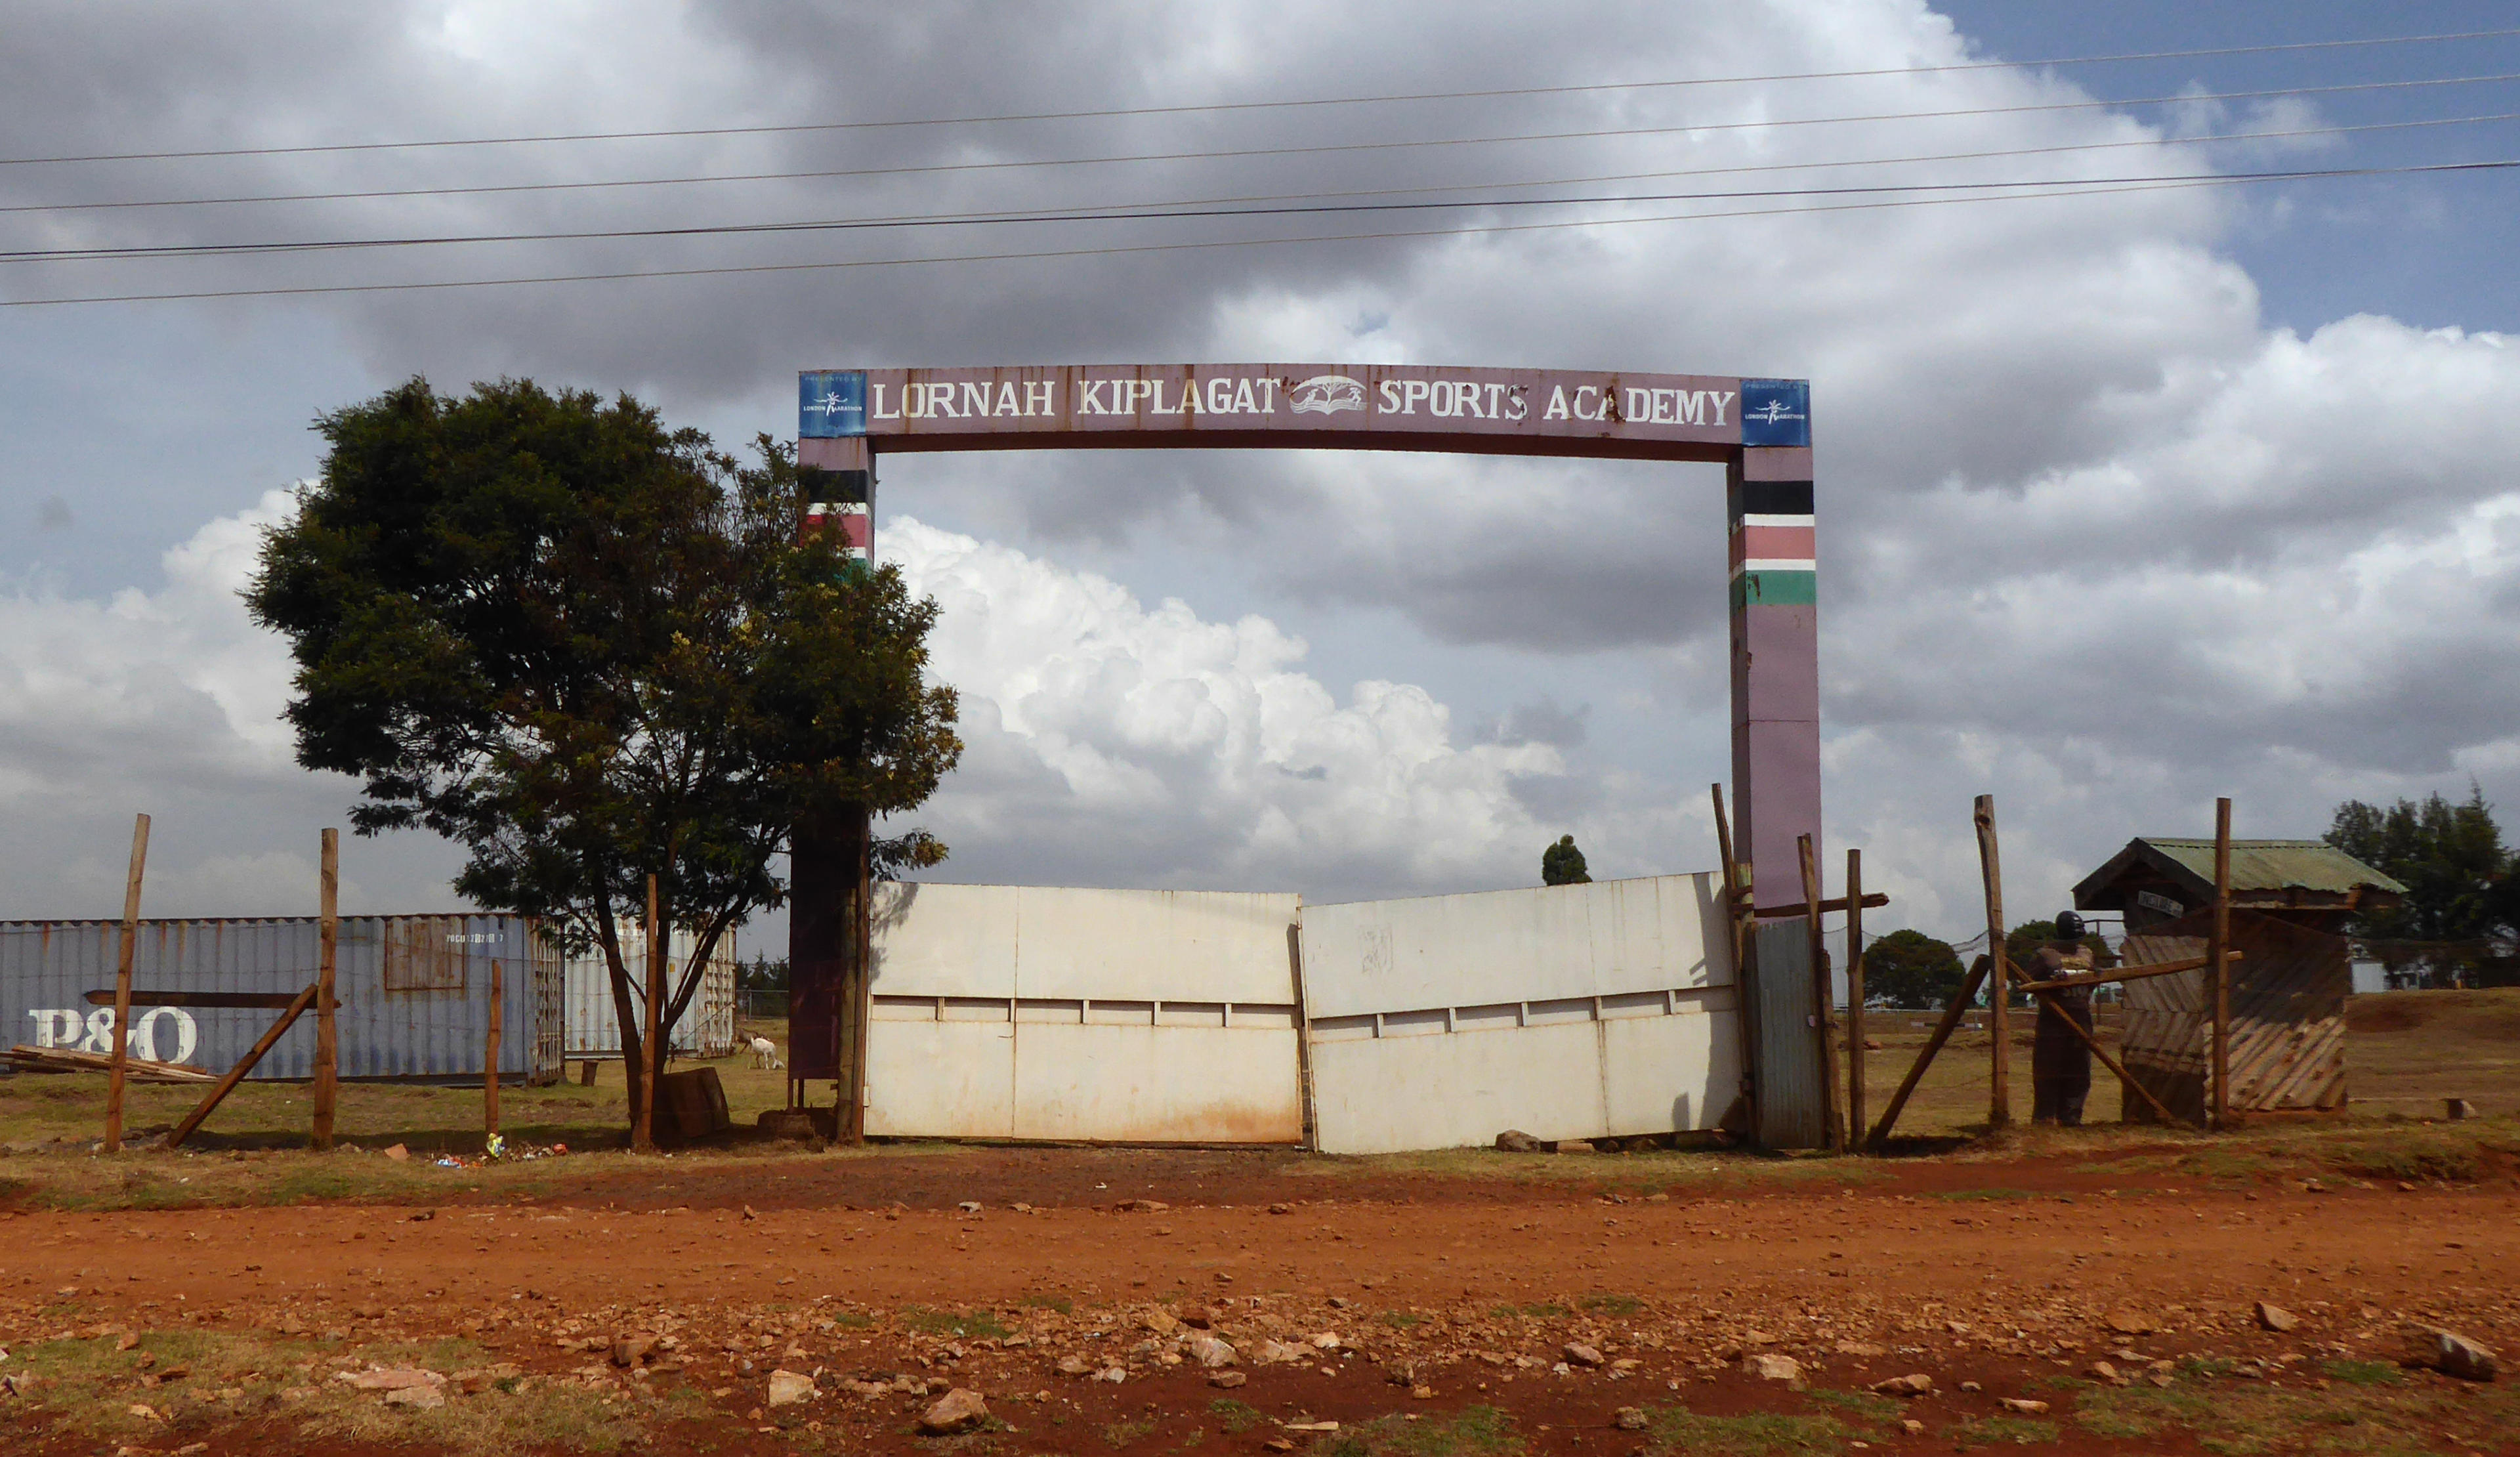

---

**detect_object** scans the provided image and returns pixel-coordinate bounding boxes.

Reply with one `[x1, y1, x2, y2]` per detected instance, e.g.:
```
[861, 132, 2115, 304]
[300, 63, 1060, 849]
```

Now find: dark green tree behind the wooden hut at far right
[2326, 786, 2520, 981]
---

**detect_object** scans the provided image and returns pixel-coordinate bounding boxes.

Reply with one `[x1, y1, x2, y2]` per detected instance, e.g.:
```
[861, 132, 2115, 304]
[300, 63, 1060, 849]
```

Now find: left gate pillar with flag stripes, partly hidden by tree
[789, 413, 874, 1124]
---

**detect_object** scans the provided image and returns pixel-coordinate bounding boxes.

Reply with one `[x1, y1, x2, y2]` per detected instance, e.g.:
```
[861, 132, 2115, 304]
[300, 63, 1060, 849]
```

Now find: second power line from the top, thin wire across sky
[10, 71, 2520, 212]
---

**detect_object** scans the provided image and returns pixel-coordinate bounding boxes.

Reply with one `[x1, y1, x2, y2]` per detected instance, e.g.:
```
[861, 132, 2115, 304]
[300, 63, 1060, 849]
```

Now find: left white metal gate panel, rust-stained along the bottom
[867, 885, 1303, 1145]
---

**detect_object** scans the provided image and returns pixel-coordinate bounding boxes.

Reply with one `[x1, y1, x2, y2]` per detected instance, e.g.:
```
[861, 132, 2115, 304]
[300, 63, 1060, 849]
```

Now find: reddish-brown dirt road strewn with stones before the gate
[0, 1149, 2520, 1454]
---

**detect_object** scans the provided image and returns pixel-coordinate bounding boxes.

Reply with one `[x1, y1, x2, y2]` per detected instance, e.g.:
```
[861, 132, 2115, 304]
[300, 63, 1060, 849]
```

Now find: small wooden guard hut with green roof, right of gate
[2074, 839, 2406, 1122]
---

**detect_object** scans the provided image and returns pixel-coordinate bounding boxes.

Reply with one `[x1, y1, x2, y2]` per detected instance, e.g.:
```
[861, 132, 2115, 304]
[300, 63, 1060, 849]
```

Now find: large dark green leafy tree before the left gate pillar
[244, 378, 963, 1129]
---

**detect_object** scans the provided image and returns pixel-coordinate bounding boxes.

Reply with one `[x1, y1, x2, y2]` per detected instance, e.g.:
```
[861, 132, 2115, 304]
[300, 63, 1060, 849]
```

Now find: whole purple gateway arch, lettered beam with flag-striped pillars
[789, 363, 1819, 1139]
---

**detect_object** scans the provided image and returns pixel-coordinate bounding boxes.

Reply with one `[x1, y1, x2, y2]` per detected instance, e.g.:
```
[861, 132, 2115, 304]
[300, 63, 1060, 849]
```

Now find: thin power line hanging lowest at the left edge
[0, 161, 2520, 308]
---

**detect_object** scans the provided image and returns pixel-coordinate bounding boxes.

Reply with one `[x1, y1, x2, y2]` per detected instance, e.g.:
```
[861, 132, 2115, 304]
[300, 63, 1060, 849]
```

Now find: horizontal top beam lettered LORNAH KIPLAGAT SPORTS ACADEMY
[799, 363, 1764, 459]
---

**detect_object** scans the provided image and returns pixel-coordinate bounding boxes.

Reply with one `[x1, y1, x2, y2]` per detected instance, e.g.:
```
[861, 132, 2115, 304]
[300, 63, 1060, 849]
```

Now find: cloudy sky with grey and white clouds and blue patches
[0, 0, 2520, 938]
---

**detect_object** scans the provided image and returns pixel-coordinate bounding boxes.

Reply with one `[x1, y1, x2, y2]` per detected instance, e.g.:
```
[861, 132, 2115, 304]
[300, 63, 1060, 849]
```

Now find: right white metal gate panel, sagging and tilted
[1303, 875, 1744, 1154]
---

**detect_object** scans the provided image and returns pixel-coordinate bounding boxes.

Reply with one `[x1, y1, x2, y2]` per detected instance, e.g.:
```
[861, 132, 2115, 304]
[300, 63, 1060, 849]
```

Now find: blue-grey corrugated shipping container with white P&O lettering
[0, 915, 562, 1079]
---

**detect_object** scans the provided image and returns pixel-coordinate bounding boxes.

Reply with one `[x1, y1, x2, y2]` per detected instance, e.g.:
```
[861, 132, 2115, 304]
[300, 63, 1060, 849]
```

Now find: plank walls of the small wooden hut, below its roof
[2119, 910, 2354, 1122]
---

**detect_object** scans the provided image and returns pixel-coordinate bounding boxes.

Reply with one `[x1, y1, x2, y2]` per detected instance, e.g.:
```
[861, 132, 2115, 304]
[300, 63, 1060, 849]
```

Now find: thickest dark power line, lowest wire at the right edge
[0, 161, 2520, 262]
